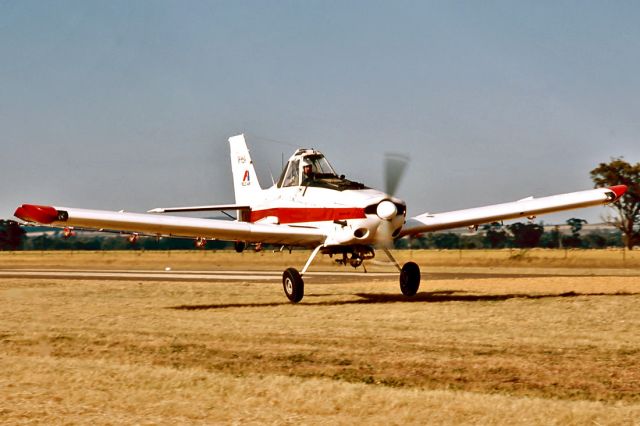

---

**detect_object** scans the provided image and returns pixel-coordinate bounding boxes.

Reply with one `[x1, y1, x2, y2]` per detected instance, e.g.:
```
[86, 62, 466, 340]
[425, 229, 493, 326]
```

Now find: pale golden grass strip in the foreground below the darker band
[5, 357, 640, 425]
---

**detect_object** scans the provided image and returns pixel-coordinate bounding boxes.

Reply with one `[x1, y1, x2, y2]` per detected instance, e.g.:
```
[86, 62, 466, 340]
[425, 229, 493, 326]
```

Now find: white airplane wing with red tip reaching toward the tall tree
[400, 185, 627, 236]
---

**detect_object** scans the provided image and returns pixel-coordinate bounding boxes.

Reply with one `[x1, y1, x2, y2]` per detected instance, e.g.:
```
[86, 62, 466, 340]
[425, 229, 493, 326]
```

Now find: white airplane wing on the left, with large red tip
[14, 204, 326, 246]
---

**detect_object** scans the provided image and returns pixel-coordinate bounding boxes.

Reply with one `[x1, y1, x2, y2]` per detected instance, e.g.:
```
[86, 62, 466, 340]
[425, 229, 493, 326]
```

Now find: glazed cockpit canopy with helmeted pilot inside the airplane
[277, 149, 365, 191]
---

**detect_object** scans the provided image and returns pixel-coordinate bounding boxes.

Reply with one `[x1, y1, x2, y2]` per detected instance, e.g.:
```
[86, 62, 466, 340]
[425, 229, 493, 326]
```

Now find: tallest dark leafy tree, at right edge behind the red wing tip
[591, 157, 640, 249]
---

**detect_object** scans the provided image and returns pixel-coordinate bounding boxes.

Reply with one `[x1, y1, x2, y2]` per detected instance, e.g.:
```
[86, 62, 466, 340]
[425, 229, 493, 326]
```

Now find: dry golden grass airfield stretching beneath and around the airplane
[0, 250, 640, 425]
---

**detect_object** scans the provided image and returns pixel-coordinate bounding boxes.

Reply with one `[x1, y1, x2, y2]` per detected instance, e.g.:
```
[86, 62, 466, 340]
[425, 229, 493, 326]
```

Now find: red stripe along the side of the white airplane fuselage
[249, 207, 366, 223]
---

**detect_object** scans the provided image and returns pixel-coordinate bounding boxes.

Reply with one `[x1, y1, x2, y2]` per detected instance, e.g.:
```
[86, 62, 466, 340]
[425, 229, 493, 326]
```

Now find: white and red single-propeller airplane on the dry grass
[14, 135, 627, 303]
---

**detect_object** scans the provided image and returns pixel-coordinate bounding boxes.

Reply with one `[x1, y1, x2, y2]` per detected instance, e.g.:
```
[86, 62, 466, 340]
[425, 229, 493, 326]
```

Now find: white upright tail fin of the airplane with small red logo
[229, 135, 262, 205]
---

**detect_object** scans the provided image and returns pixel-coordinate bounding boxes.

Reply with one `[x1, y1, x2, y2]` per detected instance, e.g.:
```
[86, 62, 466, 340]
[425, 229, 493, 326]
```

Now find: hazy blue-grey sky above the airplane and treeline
[0, 0, 640, 222]
